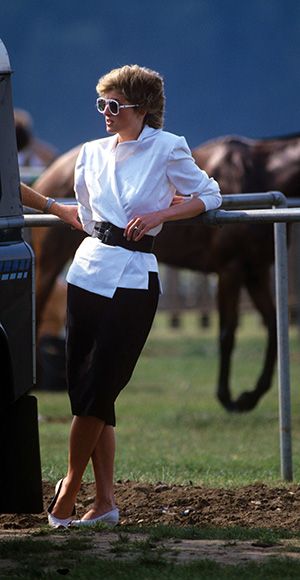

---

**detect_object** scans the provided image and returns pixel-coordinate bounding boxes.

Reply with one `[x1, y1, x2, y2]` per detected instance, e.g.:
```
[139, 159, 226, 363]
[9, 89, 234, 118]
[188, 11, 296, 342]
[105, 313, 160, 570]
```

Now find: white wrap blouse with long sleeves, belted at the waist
[67, 125, 222, 298]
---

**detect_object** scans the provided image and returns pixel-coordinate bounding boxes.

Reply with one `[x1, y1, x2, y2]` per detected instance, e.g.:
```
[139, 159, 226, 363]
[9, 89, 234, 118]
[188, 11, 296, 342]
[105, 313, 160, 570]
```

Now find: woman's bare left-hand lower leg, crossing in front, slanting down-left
[52, 416, 105, 519]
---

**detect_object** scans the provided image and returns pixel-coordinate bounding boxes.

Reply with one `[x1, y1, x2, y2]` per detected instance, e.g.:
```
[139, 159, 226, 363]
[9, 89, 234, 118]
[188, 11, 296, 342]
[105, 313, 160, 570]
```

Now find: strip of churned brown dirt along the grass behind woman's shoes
[0, 481, 300, 531]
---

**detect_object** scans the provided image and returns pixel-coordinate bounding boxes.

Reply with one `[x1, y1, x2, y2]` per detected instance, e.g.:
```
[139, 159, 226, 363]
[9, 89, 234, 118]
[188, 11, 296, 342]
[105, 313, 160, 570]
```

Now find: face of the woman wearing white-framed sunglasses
[101, 91, 145, 141]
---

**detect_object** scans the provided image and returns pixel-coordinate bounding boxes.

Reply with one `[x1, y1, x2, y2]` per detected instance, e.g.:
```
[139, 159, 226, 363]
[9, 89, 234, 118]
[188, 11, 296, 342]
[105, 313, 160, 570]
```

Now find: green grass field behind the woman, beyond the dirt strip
[38, 313, 300, 486]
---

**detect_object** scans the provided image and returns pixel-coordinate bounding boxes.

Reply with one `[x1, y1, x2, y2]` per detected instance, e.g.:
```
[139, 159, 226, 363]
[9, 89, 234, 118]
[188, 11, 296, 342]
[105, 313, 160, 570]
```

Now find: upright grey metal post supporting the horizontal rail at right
[274, 223, 293, 481]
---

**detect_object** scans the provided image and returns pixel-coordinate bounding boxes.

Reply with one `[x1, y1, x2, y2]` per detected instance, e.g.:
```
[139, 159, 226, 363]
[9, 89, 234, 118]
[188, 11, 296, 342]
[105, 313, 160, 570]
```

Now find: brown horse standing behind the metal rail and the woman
[29, 135, 300, 411]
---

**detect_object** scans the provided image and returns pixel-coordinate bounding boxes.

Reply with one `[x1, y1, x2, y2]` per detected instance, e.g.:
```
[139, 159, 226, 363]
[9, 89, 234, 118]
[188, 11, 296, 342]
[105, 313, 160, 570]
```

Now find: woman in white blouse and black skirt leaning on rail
[48, 65, 221, 527]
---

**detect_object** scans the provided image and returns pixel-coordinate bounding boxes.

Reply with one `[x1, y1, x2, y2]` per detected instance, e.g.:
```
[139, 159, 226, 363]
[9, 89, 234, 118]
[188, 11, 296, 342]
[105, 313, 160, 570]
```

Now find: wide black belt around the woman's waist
[92, 222, 154, 254]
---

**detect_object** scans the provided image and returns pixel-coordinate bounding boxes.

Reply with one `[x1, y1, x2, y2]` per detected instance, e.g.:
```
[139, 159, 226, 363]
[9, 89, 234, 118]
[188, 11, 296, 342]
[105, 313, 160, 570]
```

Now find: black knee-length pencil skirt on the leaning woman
[66, 272, 159, 425]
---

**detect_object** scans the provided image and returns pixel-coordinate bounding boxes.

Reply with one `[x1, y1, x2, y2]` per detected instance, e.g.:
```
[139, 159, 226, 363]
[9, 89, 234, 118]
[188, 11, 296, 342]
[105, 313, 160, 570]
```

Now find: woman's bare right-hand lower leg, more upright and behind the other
[82, 425, 115, 520]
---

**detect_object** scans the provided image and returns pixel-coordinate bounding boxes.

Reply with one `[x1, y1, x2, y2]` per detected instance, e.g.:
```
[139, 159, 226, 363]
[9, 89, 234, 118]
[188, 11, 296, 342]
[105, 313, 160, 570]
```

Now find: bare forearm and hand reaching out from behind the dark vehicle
[21, 183, 82, 230]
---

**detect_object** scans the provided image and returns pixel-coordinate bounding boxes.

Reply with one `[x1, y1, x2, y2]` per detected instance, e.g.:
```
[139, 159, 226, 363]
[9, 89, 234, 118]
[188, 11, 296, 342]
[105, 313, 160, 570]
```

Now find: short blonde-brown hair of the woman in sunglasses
[96, 64, 165, 129]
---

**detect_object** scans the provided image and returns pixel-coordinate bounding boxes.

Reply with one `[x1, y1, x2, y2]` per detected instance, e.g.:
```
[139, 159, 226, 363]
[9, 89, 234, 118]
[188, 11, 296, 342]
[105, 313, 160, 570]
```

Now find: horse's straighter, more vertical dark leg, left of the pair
[217, 264, 243, 411]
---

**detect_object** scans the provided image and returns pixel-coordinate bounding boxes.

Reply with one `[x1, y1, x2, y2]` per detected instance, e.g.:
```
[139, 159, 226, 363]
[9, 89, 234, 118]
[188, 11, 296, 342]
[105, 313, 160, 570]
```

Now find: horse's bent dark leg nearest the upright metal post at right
[236, 270, 277, 411]
